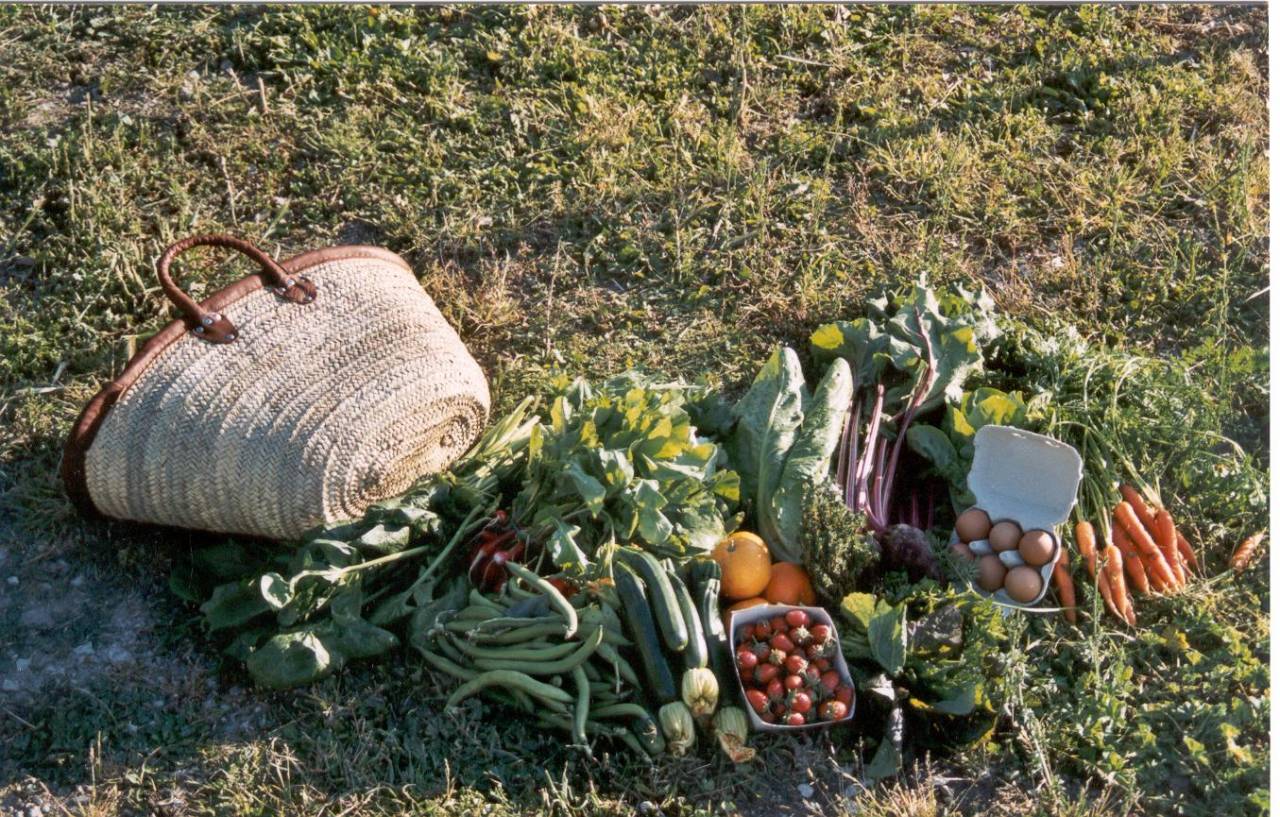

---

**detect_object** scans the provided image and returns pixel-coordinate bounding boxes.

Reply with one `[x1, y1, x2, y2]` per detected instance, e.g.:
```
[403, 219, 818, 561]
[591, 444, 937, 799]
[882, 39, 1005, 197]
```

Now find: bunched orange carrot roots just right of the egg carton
[1053, 485, 1199, 625]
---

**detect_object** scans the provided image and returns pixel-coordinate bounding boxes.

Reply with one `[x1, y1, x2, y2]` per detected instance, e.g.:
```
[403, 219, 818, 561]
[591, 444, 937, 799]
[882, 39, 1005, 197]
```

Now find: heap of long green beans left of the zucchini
[417, 562, 666, 757]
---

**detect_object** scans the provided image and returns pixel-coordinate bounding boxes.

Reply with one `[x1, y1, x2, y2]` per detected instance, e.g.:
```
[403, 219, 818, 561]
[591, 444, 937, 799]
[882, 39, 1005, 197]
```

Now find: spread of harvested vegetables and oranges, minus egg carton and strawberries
[173, 276, 1263, 779]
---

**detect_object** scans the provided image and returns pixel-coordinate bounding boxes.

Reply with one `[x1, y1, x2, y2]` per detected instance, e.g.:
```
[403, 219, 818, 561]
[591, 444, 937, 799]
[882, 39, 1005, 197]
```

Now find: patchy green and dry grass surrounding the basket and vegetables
[0, 6, 1270, 816]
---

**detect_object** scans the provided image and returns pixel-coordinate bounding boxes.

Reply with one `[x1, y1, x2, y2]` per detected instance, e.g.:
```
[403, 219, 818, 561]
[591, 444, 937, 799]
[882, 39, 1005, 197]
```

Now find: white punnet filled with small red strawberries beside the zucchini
[733, 610, 854, 726]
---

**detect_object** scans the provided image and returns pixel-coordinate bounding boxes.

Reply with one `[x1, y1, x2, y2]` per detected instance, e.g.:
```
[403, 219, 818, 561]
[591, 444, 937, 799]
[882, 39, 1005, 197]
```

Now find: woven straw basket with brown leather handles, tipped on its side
[63, 236, 489, 539]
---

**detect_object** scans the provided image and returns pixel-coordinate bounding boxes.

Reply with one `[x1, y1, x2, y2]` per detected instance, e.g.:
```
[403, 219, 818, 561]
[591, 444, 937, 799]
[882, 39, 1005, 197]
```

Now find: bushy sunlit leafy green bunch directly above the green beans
[512, 373, 739, 572]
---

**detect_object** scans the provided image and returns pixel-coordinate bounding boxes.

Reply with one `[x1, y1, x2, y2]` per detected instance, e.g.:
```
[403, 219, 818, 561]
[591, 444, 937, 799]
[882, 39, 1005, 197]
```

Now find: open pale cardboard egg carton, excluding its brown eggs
[951, 425, 1084, 607]
